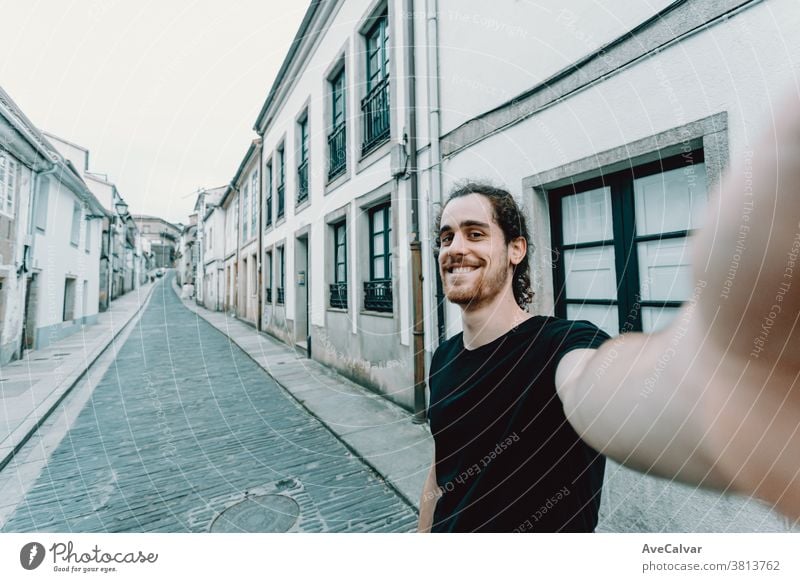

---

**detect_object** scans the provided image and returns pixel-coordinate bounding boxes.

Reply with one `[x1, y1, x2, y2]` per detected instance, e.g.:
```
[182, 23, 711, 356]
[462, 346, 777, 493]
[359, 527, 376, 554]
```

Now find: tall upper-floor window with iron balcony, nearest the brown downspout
[361, 12, 389, 155]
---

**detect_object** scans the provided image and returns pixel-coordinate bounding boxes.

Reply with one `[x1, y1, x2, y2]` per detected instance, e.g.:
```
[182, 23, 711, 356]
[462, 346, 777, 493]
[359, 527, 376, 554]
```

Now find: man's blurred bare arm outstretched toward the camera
[556, 96, 800, 518]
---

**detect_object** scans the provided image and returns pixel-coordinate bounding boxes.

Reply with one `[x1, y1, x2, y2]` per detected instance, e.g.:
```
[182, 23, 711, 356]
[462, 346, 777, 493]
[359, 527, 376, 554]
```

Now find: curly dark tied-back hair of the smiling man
[434, 181, 533, 309]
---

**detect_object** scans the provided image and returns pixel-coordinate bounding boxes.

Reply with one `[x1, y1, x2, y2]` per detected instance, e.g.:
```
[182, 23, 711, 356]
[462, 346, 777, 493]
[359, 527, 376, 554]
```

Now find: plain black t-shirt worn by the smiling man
[429, 316, 609, 532]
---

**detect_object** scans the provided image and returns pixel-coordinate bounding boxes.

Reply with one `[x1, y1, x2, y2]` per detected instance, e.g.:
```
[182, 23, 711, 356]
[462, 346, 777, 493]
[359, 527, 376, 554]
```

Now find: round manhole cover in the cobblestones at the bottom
[211, 495, 300, 533]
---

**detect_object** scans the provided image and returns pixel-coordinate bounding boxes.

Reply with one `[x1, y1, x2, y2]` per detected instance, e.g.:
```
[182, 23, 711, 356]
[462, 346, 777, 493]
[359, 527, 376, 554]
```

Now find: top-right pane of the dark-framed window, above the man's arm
[633, 164, 708, 236]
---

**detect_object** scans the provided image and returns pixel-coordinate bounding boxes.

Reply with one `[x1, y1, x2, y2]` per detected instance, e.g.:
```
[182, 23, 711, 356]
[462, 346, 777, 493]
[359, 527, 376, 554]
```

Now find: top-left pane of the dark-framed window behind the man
[561, 188, 614, 245]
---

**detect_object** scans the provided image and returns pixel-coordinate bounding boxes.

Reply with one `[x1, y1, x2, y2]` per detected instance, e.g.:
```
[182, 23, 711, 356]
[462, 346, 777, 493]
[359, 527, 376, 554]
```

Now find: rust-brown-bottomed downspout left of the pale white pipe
[405, 0, 427, 424]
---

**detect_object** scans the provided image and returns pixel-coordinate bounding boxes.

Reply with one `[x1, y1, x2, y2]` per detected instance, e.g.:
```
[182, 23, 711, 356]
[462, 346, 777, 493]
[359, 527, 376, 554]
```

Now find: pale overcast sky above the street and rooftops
[0, 0, 309, 223]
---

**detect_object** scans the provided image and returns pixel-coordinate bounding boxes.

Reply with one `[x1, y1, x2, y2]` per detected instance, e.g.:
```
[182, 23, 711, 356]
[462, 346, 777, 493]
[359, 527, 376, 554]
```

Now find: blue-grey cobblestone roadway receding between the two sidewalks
[2, 278, 417, 532]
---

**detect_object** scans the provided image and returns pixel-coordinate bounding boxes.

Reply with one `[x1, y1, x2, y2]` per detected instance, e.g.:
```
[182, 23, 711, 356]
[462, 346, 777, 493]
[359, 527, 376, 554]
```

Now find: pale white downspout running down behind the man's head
[427, 0, 446, 343]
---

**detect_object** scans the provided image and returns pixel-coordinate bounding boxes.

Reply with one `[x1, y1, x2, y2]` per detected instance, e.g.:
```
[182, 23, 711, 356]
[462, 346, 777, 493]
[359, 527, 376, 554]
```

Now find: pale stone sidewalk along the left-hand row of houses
[0, 280, 160, 470]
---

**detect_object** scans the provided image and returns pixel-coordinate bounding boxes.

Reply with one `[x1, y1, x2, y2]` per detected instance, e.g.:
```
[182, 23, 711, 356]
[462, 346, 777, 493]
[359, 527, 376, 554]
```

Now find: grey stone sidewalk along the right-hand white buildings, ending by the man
[179, 286, 433, 509]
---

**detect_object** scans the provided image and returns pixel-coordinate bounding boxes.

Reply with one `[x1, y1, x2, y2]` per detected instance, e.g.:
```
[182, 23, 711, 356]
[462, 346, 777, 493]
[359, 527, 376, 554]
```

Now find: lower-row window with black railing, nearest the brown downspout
[364, 204, 392, 311]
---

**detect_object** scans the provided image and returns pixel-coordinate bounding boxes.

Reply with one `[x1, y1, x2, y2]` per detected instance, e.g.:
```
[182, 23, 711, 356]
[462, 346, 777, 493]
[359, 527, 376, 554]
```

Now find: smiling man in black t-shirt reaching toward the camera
[419, 102, 800, 532]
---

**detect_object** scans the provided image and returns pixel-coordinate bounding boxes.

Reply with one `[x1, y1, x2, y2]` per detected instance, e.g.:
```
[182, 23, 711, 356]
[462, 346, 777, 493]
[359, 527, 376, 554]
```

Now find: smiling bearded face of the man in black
[439, 194, 518, 309]
